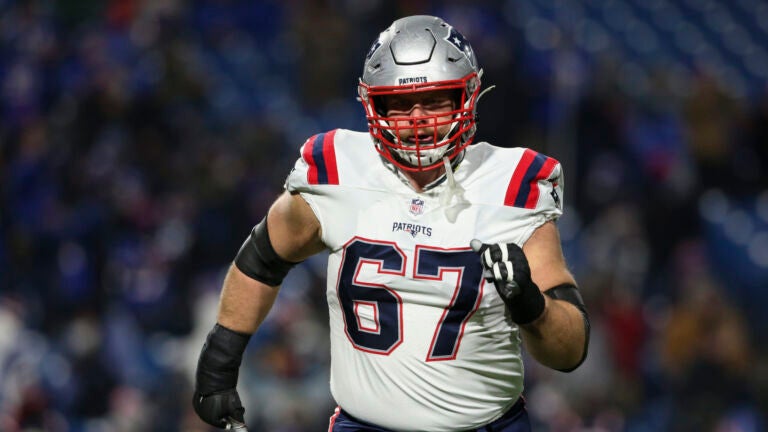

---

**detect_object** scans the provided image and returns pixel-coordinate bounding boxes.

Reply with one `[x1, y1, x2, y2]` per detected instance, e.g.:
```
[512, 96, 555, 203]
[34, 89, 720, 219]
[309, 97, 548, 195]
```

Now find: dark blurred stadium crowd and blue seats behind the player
[0, 0, 768, 432]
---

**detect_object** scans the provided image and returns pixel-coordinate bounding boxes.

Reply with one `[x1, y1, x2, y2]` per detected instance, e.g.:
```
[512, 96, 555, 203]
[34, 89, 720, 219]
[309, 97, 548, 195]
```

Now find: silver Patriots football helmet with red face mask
[358, 15, 482, 171]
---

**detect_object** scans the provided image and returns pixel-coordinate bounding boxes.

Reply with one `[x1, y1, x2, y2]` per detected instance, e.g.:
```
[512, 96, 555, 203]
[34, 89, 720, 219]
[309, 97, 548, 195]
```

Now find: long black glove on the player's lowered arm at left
[192, 324, 250, 428]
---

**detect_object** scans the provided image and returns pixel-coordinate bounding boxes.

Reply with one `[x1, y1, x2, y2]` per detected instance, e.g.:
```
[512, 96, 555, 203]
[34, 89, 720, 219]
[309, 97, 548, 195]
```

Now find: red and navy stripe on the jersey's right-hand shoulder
[504, 149, 558, 209]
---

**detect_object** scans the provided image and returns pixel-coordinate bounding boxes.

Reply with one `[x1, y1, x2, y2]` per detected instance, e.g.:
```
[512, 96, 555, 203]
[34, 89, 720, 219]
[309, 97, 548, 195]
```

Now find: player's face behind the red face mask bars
[384, 90, 456, 145]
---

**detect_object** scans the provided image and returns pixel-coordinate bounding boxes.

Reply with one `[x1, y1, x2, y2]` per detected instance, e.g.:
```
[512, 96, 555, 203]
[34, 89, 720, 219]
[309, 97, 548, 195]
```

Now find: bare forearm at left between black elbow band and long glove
[217, 265, 279, 334]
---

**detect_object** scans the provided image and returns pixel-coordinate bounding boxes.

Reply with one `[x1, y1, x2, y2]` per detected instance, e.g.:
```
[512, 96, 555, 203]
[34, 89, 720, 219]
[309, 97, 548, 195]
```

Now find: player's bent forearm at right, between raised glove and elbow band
[520, 296, 586, 370]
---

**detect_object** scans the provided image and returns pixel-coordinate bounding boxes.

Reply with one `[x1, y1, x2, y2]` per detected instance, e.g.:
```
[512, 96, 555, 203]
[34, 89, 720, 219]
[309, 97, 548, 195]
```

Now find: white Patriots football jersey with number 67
[286, 129, 563, 431]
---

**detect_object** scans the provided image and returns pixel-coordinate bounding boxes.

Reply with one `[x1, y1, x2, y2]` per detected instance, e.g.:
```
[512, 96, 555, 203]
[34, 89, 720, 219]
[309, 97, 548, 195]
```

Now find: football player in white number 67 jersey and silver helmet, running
[193, 16, 589, 432]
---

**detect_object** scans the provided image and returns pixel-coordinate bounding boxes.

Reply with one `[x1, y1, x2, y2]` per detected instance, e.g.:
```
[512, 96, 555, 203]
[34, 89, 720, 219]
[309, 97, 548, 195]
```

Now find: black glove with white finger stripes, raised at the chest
[470, 239, 545, 324]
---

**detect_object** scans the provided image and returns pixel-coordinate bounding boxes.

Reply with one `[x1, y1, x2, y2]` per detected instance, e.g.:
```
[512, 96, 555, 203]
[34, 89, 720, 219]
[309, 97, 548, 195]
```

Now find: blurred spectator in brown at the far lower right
[661, 244, 760, 431]
